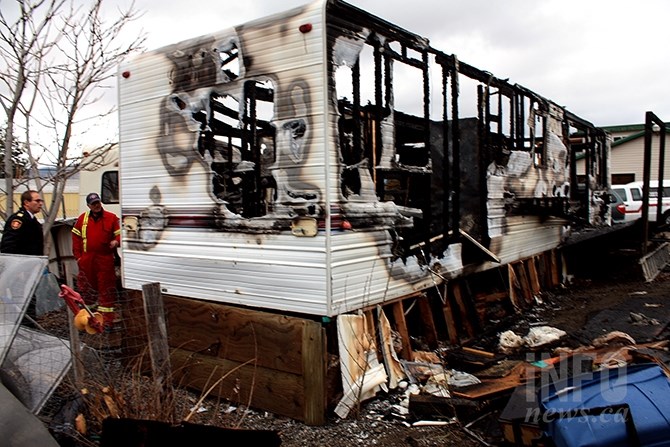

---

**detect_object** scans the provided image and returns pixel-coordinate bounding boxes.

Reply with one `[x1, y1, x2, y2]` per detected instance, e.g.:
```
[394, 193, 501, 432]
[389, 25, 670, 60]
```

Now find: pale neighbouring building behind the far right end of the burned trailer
[577, 124, 670, 185]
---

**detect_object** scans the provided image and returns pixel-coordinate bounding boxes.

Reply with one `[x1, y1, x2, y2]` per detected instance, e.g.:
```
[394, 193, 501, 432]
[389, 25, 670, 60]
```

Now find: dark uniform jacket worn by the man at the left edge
[0, 207, 44, 256]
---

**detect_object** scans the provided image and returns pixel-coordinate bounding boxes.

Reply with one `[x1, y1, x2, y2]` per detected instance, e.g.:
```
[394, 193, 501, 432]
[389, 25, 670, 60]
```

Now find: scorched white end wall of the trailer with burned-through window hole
[120, 4, 328, 314]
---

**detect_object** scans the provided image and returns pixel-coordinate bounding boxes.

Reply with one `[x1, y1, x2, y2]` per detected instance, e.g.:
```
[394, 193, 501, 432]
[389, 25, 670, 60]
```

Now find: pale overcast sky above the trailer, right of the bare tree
[115, 0, 670, 126]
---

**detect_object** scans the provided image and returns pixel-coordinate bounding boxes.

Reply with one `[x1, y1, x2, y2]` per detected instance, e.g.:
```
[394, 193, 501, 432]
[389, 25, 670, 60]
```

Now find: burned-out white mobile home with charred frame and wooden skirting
[119, 0, 609, 423]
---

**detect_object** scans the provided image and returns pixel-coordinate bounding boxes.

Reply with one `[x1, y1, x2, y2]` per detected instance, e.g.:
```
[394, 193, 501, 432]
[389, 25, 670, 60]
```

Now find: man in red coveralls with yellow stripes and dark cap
[72, 192, 121, 329]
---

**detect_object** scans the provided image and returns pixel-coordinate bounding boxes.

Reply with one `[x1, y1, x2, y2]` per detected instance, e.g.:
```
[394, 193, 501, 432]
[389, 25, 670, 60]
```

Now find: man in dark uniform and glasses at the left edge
[0, 190, 44, 256]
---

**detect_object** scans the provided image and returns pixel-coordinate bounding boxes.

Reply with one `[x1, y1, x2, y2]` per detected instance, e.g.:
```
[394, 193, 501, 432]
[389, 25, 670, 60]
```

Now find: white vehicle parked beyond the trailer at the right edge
[612, 180, 670, 224]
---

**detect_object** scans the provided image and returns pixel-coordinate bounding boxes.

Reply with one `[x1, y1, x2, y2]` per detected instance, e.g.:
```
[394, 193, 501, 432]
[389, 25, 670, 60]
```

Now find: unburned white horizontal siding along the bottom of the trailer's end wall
[123, 230, 328, 315]
